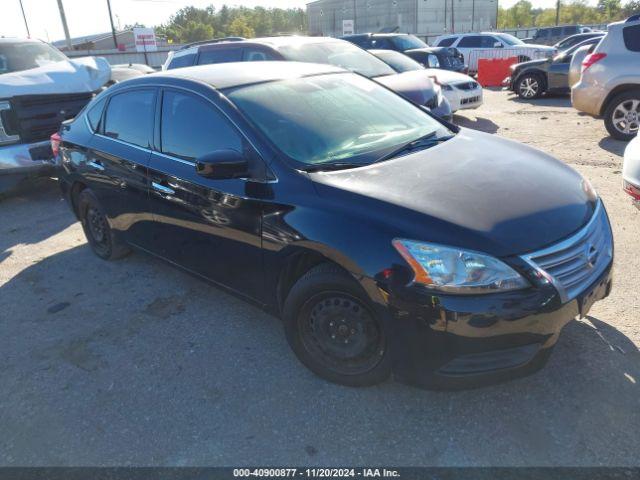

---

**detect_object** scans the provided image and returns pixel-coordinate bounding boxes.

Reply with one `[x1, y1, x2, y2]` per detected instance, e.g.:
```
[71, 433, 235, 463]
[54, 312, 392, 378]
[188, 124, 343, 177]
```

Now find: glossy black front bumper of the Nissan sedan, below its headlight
[378, 265, 612, 389]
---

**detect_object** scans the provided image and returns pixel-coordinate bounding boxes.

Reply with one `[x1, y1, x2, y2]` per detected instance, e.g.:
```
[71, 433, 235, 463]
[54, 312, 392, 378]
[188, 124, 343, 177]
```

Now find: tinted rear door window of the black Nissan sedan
[104, 90, 155, 148]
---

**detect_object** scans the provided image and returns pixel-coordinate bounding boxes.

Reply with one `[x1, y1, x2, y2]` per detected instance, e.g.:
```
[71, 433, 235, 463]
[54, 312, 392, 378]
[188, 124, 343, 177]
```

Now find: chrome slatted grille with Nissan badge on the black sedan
[523, 202, 613, 302]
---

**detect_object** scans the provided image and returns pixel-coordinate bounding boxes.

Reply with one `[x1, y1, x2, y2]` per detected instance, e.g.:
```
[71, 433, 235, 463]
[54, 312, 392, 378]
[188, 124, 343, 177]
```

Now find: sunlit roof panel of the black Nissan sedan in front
[141, 62, 348, 89]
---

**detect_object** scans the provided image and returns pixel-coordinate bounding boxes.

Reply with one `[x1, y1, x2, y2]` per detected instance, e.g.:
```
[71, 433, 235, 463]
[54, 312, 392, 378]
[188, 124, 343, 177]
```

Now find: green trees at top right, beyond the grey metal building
[498, 0, 640, 30]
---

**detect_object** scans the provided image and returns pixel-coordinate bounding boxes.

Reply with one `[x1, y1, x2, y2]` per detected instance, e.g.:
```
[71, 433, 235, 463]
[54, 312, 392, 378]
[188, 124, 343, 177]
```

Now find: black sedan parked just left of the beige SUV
[508, 36, 602, 100]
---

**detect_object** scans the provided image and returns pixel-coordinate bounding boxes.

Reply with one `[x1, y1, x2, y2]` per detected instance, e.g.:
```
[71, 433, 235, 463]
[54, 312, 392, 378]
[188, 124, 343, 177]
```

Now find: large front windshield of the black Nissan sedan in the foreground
[226, 73, 452, 169]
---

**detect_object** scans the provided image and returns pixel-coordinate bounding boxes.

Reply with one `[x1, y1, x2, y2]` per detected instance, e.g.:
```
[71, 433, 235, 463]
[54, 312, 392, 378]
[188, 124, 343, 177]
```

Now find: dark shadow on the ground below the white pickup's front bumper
[0, 178, 76, 262]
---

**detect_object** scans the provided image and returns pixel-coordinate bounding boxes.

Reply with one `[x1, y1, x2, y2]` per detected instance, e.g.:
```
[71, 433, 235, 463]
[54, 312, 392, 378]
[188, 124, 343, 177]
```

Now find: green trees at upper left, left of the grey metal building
[156, 5, 307, 43]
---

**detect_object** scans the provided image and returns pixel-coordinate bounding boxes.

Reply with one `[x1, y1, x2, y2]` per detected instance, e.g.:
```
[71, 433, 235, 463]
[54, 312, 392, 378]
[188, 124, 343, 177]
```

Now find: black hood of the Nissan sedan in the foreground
[310, 129, 596, 257]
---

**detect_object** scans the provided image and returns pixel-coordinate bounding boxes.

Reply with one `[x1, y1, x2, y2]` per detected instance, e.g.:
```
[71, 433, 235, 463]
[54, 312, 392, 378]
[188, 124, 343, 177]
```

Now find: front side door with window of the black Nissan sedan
[149, 88, 263, 298]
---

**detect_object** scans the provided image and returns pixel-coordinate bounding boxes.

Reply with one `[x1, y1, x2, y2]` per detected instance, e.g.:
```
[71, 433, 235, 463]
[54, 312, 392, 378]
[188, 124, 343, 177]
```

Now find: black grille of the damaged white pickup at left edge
[3, 92, 93, 143]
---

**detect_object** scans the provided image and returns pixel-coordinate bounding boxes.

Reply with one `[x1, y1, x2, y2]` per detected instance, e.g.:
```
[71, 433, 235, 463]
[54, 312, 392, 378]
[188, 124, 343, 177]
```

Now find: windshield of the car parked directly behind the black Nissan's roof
[279, 41, 395, 78]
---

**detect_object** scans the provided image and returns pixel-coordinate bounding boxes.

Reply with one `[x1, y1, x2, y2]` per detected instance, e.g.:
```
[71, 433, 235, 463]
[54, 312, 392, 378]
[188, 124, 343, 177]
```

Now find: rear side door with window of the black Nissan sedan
[84, 88, 157, 248]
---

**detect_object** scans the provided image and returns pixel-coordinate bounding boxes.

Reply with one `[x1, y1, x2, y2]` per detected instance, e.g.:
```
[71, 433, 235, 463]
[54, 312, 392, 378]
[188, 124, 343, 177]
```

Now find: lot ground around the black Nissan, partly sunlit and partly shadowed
[0, 91, 640, 466]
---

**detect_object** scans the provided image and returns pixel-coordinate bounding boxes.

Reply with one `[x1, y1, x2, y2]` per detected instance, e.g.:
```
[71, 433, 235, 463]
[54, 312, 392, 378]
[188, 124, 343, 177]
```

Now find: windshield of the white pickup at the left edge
[0, 42, 67, 75]
